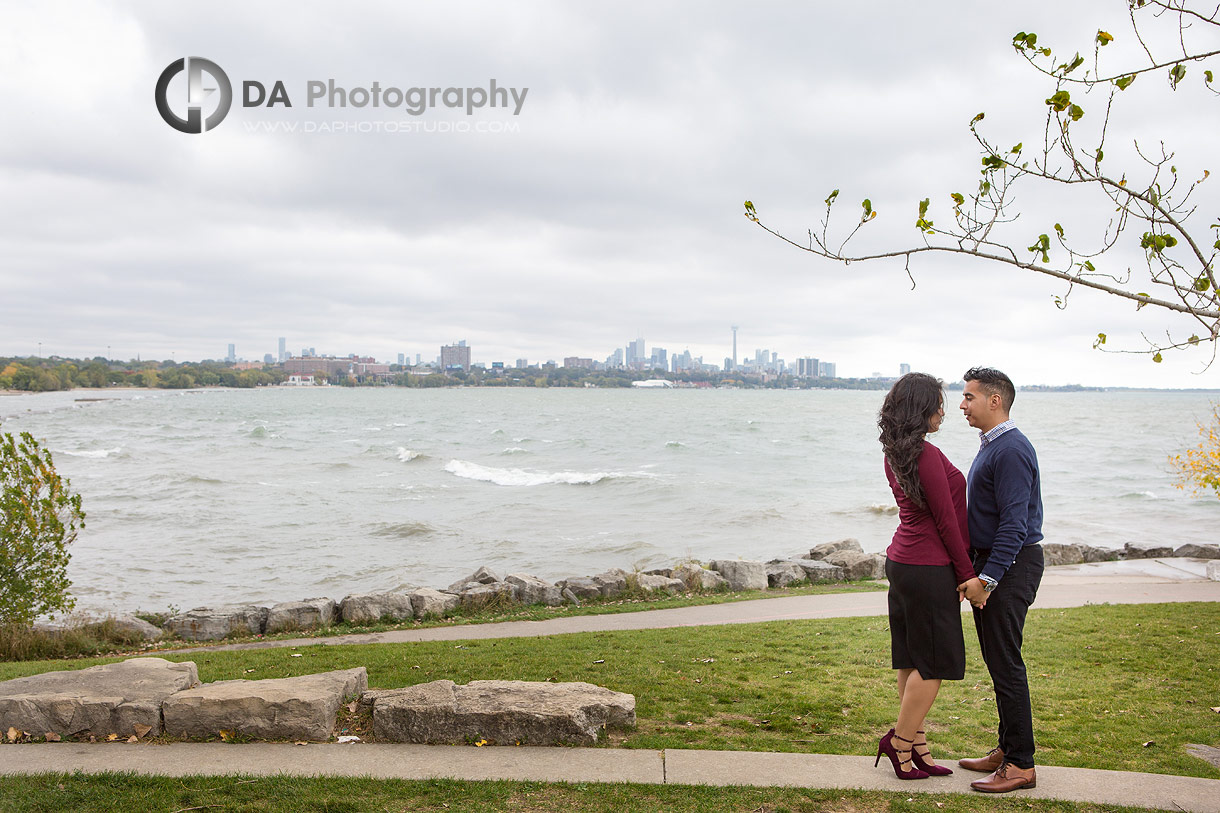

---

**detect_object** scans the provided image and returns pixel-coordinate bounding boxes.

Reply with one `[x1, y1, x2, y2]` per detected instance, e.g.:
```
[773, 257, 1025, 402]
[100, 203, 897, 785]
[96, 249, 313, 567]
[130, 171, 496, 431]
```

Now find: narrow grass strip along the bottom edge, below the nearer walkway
[0, 774, 1176, 813]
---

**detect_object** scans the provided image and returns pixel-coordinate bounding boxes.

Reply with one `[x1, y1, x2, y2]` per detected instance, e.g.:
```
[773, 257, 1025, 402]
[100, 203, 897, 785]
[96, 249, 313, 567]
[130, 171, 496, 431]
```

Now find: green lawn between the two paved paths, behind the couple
[0, 603, 1220, 778]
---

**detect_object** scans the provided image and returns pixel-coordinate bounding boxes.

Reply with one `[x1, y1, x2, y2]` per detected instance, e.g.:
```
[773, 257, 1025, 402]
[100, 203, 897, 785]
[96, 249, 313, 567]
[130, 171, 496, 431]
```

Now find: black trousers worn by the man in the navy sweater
[970, 544, 1043, 768]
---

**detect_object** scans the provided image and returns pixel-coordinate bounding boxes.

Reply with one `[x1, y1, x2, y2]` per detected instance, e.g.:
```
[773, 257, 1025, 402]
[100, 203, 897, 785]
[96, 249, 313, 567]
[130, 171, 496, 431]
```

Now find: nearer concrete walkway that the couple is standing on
[0, 742, 1220, 813]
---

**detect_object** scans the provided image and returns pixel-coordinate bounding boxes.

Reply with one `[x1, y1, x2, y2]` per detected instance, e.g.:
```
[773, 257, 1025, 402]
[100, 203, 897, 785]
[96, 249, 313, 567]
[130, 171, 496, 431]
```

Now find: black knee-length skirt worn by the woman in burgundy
[886, 559, 966, 680]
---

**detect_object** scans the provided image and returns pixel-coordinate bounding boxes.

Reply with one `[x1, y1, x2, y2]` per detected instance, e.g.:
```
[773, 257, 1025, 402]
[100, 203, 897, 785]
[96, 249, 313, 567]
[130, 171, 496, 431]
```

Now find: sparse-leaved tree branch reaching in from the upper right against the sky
[744, 0, 1220, 361]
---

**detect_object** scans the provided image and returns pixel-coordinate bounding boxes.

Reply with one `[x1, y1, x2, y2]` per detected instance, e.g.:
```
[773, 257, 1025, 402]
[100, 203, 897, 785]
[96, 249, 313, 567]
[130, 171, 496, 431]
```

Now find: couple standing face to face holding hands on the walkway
[874, 367, 1043, 793]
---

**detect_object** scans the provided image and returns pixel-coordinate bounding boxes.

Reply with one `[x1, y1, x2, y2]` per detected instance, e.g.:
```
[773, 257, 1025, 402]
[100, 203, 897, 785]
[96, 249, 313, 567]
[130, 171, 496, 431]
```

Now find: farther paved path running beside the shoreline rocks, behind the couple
[187, 559, 1220, 652]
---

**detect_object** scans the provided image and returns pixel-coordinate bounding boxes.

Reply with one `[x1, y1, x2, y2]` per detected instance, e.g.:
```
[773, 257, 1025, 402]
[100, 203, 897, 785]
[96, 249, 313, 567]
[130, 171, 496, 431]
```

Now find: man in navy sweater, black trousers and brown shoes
[958, 367, 1043, 793]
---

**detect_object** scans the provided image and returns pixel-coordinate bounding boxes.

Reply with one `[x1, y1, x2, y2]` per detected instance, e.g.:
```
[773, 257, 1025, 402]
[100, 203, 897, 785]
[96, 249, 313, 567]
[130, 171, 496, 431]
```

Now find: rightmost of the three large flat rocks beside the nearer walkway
[372, 680, 636, 746]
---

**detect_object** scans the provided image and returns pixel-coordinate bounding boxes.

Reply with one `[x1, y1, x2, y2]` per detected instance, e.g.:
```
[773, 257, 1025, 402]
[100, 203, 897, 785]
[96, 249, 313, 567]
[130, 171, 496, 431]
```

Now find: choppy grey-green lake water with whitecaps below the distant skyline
[0, 388, 1220, 610]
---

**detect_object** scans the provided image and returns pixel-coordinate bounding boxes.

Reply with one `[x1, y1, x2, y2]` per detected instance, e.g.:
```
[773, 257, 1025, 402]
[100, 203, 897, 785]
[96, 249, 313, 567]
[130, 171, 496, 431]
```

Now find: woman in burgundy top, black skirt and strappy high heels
[874, 372, 975, 779]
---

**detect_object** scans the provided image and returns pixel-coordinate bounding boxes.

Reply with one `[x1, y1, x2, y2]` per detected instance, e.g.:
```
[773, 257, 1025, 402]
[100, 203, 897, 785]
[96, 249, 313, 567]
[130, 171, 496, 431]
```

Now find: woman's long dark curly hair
[877, 372, 944, 508]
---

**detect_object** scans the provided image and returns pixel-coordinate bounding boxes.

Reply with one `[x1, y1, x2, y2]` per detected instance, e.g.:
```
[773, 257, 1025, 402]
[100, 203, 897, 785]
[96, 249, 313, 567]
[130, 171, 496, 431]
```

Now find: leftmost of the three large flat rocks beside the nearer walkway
[0, 658, 199, 739]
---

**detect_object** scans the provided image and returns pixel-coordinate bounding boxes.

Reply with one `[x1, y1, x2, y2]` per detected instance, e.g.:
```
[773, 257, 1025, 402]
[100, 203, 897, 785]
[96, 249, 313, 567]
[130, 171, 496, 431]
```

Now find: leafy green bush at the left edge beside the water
[0, 419, 84, 626]
